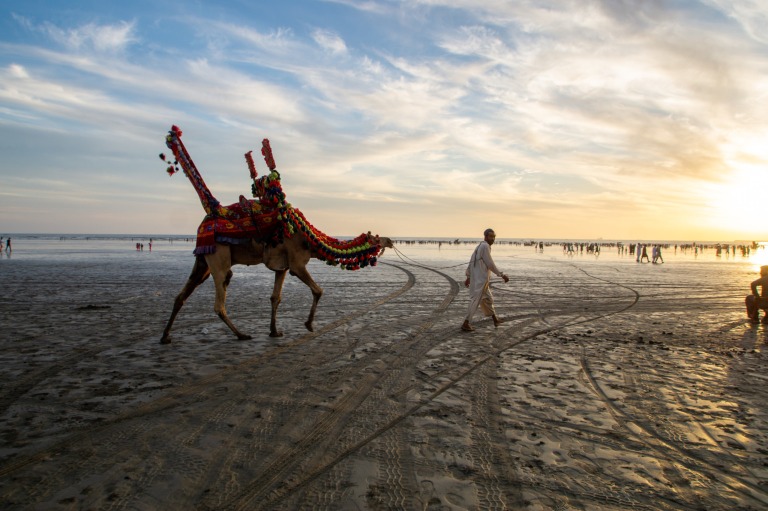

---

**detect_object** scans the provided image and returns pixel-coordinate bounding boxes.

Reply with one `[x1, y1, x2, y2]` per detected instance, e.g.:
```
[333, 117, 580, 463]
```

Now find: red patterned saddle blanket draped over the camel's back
[194, 195, 282, 255]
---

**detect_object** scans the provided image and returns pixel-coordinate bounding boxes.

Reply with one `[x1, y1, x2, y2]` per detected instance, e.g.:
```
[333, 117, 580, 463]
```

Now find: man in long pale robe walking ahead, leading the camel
[461, 229, 509, 332]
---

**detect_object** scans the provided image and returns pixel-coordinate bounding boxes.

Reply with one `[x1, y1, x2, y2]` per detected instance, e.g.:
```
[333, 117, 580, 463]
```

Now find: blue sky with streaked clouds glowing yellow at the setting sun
[0, 0, 768, 241]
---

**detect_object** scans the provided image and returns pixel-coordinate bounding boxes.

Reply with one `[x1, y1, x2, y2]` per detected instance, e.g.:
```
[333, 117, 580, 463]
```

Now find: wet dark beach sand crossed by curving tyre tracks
[0, 240, 768, 511]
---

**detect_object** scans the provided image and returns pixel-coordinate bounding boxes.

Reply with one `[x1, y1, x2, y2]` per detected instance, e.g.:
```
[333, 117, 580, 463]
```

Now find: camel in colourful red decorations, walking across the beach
[160, 126, 393, 344]
